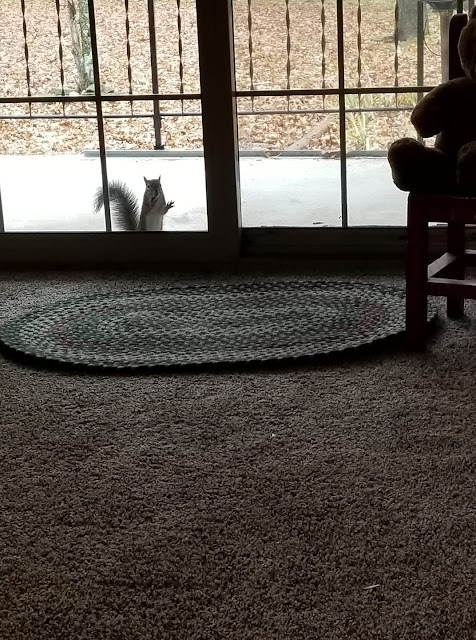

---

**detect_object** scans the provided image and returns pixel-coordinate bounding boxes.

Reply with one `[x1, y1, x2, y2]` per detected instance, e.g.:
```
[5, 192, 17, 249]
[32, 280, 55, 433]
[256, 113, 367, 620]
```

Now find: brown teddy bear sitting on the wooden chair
[388, 6, 476, 195]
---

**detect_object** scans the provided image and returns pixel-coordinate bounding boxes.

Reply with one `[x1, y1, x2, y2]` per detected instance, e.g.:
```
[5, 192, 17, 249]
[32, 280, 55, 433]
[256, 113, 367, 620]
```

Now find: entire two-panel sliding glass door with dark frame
[0, 0, 464, 264]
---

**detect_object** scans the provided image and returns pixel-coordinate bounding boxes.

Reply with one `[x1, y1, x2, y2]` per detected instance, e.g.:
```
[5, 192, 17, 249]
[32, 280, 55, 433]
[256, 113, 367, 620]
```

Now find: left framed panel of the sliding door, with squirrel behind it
[0, 0, 239, 263]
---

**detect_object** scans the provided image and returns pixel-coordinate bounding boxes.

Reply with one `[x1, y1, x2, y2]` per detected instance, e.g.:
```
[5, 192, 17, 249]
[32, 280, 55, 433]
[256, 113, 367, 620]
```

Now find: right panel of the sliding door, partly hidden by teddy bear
[233, 0, 464, 256]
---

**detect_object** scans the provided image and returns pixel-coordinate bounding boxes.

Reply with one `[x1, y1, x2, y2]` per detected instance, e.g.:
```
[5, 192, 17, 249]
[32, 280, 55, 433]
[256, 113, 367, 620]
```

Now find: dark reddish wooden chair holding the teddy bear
[406, 14, 476, 351]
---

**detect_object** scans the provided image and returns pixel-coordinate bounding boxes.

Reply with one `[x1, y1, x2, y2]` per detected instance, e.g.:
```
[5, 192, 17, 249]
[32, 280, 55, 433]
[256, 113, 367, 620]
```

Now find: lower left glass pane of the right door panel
[239, 98, 341, 227]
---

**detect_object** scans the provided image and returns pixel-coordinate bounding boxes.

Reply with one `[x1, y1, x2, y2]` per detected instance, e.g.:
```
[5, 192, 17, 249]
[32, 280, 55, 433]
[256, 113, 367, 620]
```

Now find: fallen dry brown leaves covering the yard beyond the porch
[0, 0, 446, 153]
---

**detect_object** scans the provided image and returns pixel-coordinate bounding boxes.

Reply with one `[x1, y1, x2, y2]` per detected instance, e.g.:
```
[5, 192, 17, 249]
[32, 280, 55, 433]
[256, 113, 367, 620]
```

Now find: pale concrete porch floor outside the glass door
[0, 155, 407, 232]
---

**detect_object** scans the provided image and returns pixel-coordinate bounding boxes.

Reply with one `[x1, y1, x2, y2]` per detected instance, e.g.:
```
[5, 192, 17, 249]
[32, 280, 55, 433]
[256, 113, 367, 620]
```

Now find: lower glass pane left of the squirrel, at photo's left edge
[0, 119, 105, 232]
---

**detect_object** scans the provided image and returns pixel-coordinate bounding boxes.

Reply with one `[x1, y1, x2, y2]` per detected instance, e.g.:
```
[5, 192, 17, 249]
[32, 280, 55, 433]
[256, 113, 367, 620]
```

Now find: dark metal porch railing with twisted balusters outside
[0, 0, 468, 139]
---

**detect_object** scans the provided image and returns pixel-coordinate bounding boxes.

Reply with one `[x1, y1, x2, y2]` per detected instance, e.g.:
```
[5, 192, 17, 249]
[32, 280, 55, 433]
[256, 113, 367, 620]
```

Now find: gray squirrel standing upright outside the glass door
[93, 176, 174, 231]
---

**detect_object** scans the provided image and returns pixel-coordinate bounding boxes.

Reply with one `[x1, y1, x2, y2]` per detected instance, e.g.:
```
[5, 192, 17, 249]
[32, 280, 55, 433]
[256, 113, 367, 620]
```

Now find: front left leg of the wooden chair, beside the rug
[405, 194, 428, 351]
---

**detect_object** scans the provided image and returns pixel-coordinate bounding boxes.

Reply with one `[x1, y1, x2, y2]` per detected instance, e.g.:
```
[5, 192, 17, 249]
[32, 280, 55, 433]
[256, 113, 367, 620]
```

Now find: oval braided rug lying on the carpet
[0, 281, 437, 368]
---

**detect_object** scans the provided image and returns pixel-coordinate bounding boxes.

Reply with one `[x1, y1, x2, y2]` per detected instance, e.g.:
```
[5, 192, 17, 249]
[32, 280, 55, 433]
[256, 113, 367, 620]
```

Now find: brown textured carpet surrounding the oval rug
[0, 274, 476, 640]
